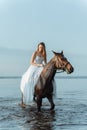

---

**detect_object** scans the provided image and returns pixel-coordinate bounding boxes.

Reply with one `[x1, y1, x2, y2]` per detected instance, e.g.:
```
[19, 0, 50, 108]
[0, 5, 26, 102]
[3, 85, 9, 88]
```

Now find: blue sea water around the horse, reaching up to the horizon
[0, 78, 87, 130]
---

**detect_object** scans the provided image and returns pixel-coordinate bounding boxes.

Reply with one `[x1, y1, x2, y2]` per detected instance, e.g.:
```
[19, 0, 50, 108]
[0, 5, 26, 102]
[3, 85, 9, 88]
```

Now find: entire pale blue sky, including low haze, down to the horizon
[0, 0, 87, 75]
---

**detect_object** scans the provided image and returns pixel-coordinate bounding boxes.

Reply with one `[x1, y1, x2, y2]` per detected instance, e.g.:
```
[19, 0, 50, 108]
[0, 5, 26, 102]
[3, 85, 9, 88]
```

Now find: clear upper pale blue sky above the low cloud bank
[0, 0, 87, 54]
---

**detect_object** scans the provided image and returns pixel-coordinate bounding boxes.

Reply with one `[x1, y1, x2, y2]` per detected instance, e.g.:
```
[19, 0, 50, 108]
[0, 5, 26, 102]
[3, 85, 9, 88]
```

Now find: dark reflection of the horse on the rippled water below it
[22, 107, 55, 130]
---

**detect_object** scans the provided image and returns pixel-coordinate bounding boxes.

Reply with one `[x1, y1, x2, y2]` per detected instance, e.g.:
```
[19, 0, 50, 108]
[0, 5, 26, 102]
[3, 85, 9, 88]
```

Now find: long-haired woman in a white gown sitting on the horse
[20, 42, 47, 107]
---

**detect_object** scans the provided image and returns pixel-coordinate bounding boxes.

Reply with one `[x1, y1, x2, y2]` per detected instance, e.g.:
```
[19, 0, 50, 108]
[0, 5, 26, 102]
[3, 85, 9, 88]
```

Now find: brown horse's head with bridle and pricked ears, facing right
[53, 51, 74, 74]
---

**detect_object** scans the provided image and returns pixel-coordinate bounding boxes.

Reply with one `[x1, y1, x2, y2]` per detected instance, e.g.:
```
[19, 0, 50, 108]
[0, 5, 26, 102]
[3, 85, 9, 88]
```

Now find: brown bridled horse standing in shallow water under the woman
[34, 51, 74, 111]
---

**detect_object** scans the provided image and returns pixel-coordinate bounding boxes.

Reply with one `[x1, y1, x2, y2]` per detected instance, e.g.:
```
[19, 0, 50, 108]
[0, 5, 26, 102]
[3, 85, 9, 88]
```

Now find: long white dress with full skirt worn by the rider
[20, 56, 44, 105]
